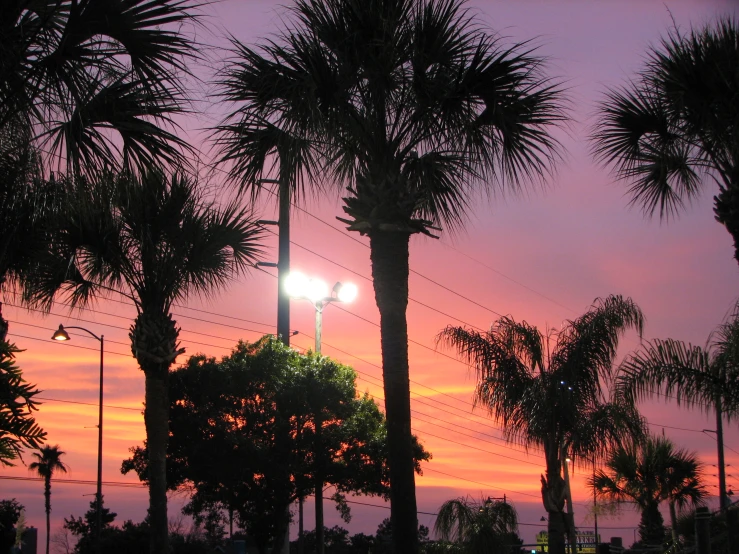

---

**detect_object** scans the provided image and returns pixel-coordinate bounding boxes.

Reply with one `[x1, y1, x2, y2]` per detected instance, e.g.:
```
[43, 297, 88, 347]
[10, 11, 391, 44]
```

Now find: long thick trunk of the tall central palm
[370, 231, 418, 554]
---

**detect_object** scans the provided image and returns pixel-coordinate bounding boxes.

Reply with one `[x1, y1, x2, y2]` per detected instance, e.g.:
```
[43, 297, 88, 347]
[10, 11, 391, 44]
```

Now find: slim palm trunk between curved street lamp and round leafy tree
[144, 372, 169, 554]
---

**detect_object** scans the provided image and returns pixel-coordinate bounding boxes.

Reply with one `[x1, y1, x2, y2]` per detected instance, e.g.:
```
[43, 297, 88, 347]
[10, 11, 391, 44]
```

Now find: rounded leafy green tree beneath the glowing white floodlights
[123, 337, 429, 551]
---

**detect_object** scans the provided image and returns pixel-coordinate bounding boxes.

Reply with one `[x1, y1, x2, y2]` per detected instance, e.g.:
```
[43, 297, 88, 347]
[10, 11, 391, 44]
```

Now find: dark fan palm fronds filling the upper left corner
[0, 0, 195, 336]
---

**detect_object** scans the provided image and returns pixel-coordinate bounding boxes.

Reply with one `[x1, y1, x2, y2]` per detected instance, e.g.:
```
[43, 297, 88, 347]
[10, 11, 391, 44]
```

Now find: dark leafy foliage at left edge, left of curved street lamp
[0, 341, 46, 466]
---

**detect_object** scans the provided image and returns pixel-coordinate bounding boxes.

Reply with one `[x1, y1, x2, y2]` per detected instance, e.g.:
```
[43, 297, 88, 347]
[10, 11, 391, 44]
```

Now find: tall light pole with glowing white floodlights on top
[283, 271, 357, 554]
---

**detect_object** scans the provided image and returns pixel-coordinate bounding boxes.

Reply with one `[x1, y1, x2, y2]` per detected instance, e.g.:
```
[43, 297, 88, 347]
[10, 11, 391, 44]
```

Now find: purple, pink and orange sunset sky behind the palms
[0, 0, 739, 544]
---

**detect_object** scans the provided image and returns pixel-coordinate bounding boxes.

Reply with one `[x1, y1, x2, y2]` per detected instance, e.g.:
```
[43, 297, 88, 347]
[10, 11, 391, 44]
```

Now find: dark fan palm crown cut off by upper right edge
[593, 17, 739, 261]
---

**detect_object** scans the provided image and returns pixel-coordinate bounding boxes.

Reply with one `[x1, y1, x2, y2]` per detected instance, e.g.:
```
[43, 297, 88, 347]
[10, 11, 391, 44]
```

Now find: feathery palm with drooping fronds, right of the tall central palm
[437, 296, 643, 554]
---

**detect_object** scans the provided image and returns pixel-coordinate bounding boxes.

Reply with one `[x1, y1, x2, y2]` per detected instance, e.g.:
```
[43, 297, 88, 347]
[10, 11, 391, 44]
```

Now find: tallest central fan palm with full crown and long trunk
[215, 0, 563, 553]
